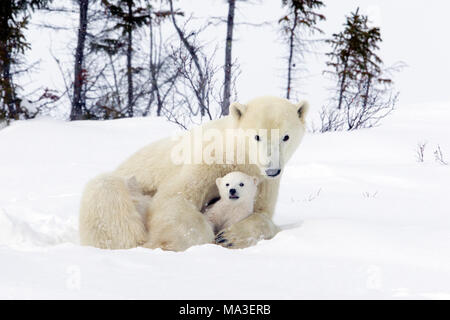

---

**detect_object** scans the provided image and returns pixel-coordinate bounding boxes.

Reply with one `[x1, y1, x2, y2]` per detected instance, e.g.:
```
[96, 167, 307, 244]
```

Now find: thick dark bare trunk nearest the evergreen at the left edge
[70, 0, 89, 120]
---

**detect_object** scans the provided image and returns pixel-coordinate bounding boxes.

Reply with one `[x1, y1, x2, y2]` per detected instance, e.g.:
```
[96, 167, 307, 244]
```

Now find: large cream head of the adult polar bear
[230, 97, 309, 179]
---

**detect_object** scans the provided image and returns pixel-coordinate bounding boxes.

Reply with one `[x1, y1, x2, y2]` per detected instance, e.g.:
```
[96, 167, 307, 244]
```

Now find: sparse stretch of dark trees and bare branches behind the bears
[0, 0, 401, 132]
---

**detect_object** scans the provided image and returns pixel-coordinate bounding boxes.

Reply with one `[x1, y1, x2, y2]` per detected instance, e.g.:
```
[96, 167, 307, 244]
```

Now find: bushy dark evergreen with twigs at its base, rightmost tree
[321, 9, 398, 131]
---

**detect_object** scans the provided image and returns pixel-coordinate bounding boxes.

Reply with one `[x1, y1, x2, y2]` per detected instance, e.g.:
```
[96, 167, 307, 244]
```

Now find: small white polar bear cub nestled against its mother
[205, 171, 259, 233]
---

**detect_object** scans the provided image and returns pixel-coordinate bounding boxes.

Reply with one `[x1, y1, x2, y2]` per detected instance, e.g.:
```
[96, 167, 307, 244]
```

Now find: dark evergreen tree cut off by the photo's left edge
[0, 0, 49, 119]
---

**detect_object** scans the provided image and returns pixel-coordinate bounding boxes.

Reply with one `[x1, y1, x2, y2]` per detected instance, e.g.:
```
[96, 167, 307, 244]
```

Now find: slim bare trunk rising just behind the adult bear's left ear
[222, 0, 236, 116]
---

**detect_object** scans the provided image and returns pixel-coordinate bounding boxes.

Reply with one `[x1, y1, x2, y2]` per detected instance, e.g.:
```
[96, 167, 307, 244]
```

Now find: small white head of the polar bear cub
[216, 171, 259, 203]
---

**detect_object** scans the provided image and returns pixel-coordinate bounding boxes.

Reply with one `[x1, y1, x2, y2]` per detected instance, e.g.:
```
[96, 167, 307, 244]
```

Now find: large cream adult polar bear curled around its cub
[80, 97, 308, 251]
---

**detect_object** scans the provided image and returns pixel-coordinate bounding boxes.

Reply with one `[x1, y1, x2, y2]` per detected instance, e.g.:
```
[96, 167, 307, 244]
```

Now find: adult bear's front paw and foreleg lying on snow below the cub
[216, 213, 279, 249]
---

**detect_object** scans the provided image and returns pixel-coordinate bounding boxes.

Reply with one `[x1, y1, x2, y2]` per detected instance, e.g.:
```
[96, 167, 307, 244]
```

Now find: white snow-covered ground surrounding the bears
[0, 104, 450, 299]
